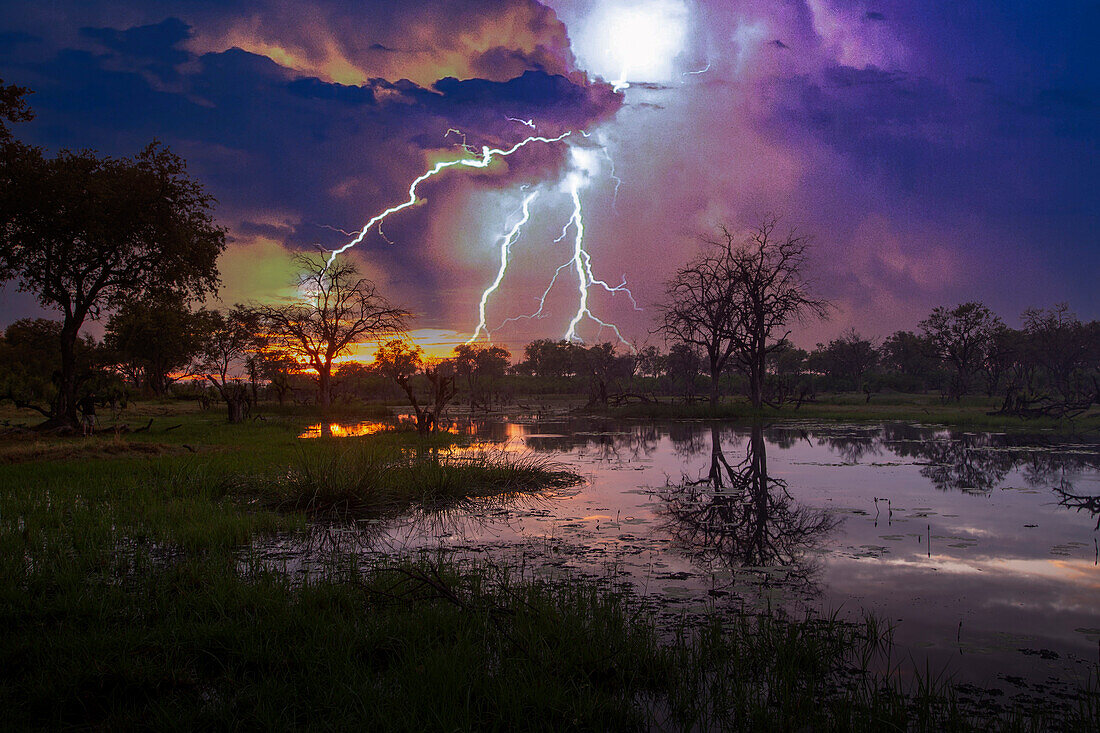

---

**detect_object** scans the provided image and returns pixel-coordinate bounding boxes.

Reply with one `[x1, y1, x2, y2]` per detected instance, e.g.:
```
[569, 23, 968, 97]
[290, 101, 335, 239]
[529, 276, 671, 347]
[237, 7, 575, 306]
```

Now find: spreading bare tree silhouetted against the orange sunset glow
[256, 254, 409, 407]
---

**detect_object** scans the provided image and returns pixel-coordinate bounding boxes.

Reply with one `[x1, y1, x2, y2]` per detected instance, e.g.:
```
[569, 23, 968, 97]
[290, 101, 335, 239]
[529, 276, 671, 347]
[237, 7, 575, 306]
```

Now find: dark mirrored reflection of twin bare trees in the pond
[661, 424, 838, 584]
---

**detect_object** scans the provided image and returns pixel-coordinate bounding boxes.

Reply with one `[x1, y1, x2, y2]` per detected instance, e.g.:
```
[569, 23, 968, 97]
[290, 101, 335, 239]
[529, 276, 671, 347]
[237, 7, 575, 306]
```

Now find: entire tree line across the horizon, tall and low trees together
[0, 76, 1100, 424]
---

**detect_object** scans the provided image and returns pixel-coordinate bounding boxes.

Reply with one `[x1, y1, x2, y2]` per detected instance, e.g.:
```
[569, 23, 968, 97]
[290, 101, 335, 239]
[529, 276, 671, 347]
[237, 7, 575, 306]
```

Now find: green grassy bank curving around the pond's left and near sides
[0, 405, 1100, 731]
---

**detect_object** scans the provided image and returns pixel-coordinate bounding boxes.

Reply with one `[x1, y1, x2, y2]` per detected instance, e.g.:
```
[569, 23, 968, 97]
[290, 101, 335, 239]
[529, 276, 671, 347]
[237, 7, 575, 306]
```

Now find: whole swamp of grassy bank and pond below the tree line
[0, 404, 1100, 730]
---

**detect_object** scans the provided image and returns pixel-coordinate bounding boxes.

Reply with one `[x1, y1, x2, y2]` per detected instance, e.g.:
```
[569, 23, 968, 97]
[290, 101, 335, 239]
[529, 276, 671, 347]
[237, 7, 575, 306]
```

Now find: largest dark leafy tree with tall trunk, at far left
[0, 134, 226, 425]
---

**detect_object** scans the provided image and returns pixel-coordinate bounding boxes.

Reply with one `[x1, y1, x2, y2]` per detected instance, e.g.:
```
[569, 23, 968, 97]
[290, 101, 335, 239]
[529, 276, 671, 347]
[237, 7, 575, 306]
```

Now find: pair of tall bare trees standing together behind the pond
[660, 218, 829, 407]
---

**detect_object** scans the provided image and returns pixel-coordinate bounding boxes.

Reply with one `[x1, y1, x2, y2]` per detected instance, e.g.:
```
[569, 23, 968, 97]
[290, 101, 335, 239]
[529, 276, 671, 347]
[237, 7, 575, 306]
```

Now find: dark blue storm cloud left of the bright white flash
[0, 9, 622, 315]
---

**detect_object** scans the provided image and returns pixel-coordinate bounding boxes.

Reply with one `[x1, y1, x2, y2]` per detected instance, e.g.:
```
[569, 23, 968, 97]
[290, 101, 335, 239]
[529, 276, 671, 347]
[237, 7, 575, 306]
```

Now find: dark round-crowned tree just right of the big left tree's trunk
[105, 294, 208, 396]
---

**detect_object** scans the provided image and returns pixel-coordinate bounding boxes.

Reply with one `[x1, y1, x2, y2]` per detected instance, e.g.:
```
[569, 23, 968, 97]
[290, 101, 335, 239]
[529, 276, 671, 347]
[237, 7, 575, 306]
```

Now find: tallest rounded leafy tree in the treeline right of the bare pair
[920, 303, 1003, 400]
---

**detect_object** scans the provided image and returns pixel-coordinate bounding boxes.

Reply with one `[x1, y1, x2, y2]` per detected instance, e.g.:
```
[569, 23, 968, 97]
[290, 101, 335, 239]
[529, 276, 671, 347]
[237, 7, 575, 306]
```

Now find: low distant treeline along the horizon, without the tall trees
[0, 300, 1100, 416]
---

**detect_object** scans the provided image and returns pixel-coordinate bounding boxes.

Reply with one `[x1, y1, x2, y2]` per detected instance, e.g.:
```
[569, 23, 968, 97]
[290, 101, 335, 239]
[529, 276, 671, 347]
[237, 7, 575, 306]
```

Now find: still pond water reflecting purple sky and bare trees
[277, 419, 1100, 694]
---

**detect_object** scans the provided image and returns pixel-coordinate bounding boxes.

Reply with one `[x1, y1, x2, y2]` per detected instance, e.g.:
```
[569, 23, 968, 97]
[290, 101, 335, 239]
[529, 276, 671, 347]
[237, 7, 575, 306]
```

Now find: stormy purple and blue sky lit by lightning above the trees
[0, 0, 1100, 347]
